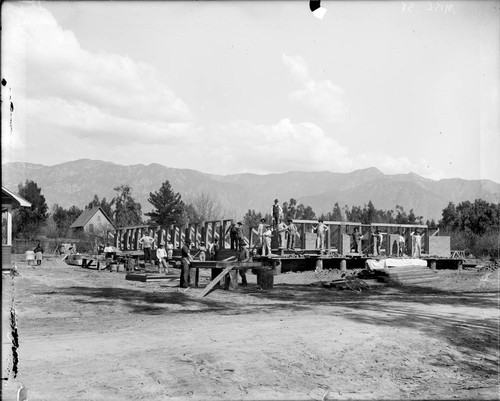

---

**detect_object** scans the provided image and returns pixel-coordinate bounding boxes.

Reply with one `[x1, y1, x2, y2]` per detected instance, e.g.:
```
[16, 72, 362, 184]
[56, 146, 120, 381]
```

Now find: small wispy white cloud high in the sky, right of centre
[282, 54, 347, 123]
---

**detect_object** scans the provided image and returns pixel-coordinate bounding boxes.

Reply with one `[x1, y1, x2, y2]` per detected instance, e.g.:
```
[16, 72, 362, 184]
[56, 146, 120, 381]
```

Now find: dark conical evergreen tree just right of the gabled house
[146, 180, 186, 225]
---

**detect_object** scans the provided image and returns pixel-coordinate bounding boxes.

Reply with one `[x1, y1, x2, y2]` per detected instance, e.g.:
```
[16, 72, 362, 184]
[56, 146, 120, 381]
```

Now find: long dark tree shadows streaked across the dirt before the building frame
[42, 276, 500, 375]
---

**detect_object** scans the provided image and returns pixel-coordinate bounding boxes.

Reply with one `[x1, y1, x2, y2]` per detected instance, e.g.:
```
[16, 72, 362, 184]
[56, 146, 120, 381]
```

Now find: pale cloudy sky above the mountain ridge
[1, 0, 500, 182]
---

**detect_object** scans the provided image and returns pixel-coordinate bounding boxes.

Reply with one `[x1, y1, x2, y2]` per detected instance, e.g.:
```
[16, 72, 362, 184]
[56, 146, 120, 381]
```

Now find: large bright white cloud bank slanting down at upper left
[2, 3, 191, 130]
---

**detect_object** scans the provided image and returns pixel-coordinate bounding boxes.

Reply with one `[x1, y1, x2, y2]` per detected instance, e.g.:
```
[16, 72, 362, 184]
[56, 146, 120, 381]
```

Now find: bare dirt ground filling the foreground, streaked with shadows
[2, 261, 500, 401]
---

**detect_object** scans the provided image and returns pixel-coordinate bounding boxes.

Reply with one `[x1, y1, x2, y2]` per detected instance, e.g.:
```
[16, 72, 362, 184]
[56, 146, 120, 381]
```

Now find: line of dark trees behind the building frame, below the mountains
[5, 180, 500, 253]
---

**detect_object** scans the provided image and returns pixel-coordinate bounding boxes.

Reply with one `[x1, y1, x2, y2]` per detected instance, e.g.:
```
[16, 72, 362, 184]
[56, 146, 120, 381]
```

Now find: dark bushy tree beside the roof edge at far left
[12, 180, 48, 238]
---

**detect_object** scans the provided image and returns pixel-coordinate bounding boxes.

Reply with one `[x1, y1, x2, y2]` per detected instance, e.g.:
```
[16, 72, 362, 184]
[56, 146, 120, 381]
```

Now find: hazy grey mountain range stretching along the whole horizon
[2, 159, 500, 221]
